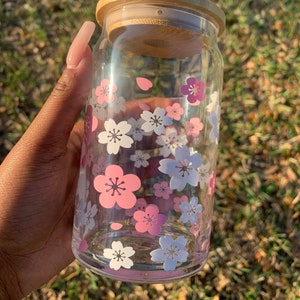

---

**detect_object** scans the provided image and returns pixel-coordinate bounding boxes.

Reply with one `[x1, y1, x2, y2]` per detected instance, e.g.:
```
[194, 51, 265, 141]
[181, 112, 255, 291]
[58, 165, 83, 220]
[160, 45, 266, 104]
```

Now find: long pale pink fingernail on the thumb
[66, 21, 95, 69]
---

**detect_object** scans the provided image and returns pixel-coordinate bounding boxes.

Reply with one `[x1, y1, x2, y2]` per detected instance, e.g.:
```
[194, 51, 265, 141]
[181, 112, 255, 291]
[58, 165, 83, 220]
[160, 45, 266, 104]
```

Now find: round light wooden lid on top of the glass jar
[96, 0, 225, 58]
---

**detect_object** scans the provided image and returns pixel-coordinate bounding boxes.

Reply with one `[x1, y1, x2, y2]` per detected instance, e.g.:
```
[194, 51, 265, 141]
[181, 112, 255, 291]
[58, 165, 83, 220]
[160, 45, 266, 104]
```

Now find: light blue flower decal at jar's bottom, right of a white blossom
[150, 235, 189, 271]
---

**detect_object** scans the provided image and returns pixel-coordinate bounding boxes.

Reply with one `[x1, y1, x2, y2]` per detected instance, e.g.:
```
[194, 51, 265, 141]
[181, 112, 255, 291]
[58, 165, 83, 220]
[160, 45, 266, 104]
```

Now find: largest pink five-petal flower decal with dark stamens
[94, 165, 141, 209]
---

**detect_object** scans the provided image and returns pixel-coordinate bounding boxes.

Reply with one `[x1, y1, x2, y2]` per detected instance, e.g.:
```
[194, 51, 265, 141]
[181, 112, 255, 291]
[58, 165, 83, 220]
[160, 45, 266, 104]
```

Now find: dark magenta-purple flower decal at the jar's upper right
[180, 77, 205, 104]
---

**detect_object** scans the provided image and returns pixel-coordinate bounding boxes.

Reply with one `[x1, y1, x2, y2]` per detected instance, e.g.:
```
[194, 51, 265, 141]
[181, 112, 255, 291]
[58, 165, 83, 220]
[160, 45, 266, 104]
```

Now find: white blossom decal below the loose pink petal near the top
[141, 107, 172, 135]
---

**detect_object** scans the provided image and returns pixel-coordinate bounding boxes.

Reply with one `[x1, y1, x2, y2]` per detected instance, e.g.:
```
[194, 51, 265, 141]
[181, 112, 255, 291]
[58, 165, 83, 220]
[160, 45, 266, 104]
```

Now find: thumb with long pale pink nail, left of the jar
[23, 22, 95, 155]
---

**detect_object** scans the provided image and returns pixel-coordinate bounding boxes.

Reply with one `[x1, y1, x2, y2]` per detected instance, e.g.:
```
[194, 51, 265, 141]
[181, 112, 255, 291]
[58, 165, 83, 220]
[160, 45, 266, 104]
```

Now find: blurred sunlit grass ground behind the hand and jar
[0, 0, 300, 300]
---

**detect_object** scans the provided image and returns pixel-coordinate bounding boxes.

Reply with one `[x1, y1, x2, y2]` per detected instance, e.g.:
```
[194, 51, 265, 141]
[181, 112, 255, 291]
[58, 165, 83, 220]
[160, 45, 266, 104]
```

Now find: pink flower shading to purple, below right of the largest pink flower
[133, 204, 167, 235]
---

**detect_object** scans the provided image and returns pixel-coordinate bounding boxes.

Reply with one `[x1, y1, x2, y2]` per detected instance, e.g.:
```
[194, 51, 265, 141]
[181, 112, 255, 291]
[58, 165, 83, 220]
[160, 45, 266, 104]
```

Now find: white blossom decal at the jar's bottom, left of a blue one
[103, 241, 135, 271]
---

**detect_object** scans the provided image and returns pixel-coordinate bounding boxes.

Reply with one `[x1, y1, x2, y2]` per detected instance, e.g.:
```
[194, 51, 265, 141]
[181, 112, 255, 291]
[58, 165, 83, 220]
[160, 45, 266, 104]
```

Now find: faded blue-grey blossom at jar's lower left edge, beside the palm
[74, 199, 98, 232]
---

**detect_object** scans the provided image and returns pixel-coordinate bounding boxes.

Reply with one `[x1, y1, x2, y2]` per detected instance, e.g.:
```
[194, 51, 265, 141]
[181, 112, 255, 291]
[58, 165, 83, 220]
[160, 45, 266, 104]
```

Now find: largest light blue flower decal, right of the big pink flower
[158, 146, 202, 191]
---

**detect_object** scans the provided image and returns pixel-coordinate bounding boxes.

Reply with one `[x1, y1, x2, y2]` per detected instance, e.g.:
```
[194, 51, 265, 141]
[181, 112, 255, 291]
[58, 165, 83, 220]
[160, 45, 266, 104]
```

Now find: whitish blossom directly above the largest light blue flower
[156, 127, 187, 157]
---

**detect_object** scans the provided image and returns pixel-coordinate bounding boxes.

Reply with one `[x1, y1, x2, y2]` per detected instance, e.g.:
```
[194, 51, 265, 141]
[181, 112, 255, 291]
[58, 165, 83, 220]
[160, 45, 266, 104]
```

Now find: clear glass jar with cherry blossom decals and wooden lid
[72, 0, 225, 283]
